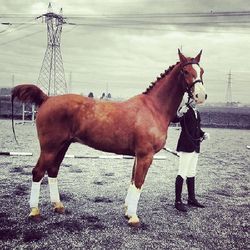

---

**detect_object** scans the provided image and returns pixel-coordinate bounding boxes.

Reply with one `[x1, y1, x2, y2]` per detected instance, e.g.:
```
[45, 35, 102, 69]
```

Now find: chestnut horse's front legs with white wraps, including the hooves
[125, 155, 153, 226]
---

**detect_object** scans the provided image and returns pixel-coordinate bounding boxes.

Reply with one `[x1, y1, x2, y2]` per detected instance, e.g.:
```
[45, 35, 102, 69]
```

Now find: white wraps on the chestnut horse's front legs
[125, 184, 141, 217]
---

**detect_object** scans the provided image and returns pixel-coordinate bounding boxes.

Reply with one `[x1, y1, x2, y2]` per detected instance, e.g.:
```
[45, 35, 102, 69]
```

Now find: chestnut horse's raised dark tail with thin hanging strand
[11, 84, 49, 144]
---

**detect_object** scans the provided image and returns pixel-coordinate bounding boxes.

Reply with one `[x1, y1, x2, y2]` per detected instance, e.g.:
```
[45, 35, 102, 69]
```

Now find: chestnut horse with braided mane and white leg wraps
[12, 51, 206, 225]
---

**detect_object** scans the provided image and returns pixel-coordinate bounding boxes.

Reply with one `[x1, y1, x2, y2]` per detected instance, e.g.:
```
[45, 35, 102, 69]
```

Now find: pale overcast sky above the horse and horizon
[0, 0, 250, 103]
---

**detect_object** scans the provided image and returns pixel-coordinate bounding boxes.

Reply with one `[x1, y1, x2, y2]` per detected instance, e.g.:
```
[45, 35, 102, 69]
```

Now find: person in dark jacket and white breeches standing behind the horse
[173, 99, 209, 212]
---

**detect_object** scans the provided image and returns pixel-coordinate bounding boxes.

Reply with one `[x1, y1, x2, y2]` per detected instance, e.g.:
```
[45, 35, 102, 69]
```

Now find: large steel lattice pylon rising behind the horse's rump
[37, 3, 68, 95]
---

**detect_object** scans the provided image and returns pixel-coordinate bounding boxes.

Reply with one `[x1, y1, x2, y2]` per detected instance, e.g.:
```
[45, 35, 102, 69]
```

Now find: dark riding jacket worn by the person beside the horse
[173, 107, 204, 153]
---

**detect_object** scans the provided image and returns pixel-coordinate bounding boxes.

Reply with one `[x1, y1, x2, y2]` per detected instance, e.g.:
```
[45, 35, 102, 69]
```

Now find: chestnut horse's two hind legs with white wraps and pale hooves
[29, 144, 69, 218]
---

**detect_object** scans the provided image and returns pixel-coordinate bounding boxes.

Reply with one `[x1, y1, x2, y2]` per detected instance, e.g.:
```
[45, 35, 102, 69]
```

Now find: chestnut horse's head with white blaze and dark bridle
[178, 50, 207, 104]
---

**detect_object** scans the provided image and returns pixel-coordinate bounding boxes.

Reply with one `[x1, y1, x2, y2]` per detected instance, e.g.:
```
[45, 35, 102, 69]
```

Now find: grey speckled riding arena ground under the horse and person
[0, 120, 250, 249]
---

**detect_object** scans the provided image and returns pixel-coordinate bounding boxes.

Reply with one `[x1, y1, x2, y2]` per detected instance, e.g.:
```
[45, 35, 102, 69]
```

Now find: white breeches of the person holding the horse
[178, 152, 199, 180]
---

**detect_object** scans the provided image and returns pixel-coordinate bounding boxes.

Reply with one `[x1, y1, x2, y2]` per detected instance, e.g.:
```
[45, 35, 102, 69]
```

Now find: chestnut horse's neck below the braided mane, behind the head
[150, 65, 184, 120]
